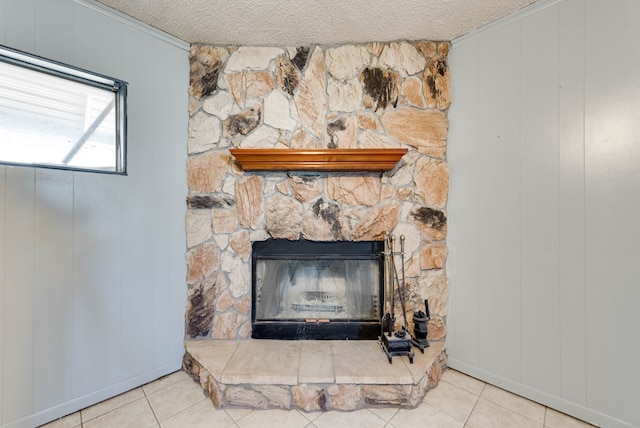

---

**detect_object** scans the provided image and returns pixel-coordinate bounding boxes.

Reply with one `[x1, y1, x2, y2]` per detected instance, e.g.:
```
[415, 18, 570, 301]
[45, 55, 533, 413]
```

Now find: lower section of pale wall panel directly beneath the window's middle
[32, 170, 73, 412]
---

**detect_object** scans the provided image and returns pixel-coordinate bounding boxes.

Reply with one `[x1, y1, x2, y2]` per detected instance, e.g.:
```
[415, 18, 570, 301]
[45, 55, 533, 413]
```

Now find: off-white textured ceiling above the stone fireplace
[92, 0, 536, 46]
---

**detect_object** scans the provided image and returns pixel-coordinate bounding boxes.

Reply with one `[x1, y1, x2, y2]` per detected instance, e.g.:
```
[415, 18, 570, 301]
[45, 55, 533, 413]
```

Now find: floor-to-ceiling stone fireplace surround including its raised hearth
[184, 41, 451, 411]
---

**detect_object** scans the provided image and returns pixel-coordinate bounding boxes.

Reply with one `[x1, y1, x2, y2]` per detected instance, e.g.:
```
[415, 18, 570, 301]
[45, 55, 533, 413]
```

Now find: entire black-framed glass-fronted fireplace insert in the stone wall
[252, 240, 384, 340]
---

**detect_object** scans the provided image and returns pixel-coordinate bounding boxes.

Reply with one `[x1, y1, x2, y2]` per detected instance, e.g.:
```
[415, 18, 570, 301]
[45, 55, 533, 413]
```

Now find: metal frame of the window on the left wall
[0, 44, 128, 175]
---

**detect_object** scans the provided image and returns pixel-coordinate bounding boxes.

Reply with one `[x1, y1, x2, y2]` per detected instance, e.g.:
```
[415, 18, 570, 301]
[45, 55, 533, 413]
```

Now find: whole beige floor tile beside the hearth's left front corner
[147, 378, 206, 423]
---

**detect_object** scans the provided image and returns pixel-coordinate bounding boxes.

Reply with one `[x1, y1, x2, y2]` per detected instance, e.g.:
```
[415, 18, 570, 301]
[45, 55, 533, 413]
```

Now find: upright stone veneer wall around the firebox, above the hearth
[186, 42, 451, 340]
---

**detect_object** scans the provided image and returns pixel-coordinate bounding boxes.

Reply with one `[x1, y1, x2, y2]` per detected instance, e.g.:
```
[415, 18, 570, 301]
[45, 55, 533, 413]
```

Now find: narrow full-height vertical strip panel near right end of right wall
[558, 0, 586, 406]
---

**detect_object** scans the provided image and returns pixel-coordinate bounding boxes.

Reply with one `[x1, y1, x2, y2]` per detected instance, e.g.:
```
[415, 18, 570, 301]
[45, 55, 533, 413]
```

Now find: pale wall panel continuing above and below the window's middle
[33, 0, 73, 413]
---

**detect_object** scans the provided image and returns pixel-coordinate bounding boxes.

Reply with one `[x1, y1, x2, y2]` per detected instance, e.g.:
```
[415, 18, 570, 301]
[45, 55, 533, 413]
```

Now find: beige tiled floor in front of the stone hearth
[40, 369, 591, 428]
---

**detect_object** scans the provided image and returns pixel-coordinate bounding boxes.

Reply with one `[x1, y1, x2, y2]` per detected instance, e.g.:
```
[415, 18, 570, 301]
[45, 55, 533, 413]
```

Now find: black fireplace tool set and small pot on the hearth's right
[379, 233, 430, 364]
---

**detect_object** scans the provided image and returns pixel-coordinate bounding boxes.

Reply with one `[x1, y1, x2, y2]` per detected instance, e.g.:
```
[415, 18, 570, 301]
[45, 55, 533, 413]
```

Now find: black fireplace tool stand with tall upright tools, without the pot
[379, 233, 414, 364]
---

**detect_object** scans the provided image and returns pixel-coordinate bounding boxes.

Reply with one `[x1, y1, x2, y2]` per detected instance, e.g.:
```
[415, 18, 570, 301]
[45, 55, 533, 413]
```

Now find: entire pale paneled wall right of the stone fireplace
[447, 0, 640, 427]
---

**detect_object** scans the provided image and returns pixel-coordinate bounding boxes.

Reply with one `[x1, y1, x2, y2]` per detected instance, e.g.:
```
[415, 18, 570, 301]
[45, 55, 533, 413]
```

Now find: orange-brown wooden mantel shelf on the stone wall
[230, 149, 407, 172]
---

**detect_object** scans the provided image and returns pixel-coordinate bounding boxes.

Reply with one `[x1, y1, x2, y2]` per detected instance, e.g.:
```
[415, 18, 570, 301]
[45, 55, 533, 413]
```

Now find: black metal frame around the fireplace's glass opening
[251, 239, 384, 340]
